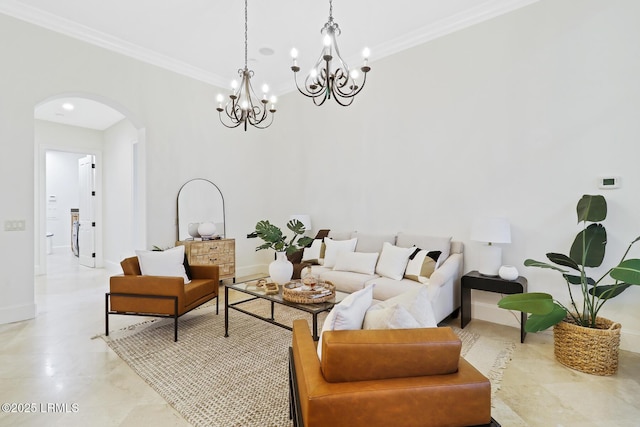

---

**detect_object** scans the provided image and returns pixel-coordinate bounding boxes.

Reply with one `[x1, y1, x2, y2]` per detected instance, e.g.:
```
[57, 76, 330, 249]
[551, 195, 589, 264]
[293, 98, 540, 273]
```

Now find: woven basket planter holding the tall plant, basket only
[553, 317, 622, 375]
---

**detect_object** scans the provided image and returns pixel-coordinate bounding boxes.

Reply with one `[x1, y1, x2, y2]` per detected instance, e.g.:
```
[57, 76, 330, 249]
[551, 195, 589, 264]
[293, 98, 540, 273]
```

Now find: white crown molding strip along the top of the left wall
[0, 0, 228, 87]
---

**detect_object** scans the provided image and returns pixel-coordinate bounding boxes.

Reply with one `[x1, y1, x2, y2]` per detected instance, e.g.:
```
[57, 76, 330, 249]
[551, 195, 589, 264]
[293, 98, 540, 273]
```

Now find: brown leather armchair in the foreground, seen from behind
[289, 320, 499, 427]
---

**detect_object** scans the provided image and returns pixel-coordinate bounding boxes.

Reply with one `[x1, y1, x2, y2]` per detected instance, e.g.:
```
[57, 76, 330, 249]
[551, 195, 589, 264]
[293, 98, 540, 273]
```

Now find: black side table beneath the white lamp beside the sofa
[460, 270, 527, 343]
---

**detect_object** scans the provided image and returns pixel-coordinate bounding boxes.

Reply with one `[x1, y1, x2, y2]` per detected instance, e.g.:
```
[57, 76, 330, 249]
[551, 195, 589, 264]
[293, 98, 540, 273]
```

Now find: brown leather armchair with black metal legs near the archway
[105, 257, 220, 341]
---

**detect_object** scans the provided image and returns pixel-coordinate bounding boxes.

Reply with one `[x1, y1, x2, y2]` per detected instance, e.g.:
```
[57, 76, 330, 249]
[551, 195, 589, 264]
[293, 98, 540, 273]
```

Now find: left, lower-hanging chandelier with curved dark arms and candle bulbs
[216, 0, 276, 131]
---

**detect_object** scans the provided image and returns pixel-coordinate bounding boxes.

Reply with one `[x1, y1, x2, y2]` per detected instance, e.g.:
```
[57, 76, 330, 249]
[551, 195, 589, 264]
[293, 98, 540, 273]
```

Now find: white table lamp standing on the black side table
[471, 218, 511, 276]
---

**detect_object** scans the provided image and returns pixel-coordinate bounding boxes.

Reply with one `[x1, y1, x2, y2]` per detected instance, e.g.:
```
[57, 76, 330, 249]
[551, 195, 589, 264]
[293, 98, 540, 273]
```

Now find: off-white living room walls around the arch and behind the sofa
[0, 0, 640, 351]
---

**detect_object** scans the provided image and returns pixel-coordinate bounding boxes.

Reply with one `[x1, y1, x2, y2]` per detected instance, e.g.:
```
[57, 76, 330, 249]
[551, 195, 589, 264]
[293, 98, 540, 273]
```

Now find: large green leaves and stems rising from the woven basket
[498, 195, 640, 332]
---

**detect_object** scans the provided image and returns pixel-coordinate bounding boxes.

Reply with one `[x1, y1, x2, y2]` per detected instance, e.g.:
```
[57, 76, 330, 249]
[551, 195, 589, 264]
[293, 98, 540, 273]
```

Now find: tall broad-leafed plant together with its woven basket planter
[498, 195, 640, 375]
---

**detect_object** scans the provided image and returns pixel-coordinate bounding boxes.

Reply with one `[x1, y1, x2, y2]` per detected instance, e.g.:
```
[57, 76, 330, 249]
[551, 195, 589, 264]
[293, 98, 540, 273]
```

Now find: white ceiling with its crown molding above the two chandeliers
[5, 0, 538, 130]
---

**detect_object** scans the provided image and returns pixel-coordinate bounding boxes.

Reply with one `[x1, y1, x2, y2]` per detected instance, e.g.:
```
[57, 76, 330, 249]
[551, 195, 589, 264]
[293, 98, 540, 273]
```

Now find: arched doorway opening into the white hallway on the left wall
[34, 93, 146, 274]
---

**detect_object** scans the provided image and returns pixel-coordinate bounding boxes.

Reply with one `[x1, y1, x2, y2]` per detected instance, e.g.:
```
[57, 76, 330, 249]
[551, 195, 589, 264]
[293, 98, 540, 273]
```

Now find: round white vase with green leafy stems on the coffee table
[255, 219, 313, 284]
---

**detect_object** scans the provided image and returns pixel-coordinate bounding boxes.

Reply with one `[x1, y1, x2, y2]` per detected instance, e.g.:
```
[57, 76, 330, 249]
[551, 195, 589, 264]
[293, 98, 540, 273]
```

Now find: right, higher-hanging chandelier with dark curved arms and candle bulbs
[291, 0, 371, 107]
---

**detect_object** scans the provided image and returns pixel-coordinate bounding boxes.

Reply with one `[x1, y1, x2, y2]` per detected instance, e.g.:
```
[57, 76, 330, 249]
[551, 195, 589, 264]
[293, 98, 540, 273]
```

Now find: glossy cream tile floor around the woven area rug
[0, 253, 640, 427]
